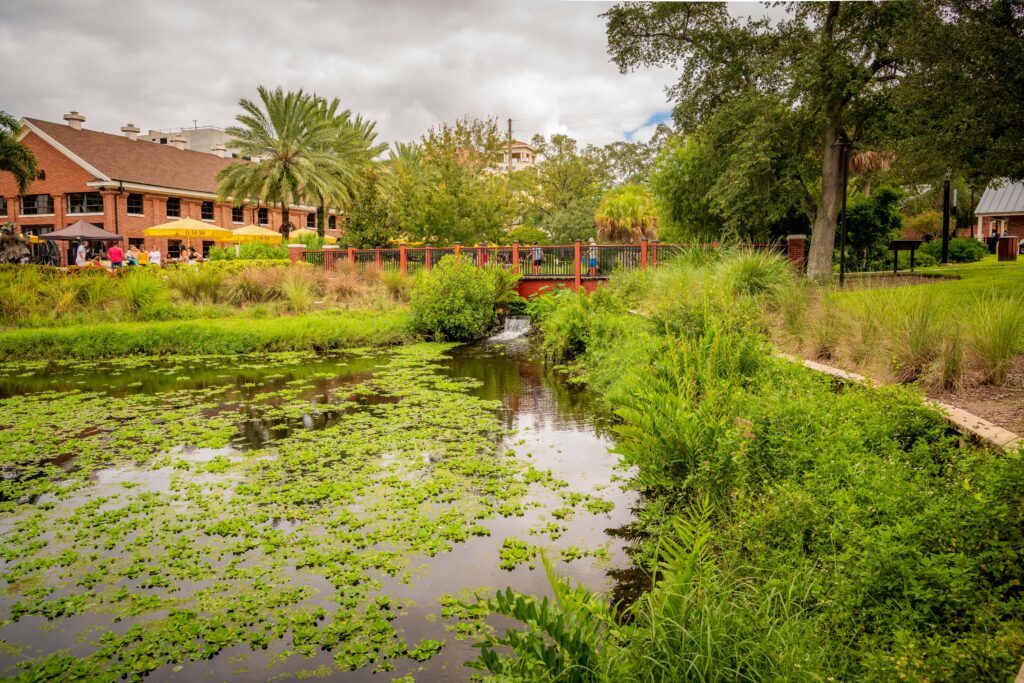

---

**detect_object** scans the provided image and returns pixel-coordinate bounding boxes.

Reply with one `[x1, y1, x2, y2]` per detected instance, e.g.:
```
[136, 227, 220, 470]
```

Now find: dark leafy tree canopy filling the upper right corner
[892, 0, 1024, 187]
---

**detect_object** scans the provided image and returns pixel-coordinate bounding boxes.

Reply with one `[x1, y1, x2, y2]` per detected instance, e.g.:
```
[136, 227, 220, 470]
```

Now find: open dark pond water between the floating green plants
[0, 339, 635, 681]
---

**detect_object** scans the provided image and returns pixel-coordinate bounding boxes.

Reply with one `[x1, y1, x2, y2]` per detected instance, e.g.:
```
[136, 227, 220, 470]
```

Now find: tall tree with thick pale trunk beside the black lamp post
[603, 2, 934, 279]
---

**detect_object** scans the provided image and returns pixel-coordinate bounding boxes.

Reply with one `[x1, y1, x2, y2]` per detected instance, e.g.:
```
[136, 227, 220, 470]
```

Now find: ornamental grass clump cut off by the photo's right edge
[968, 292, 1024, 385]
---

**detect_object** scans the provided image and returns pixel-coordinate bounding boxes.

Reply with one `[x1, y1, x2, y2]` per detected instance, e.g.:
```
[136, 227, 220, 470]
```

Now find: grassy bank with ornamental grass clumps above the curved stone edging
[772, 256, 1024, 432]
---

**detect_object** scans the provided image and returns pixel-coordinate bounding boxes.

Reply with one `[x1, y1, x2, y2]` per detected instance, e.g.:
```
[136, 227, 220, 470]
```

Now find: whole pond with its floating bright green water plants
[0, 329, 635, 681]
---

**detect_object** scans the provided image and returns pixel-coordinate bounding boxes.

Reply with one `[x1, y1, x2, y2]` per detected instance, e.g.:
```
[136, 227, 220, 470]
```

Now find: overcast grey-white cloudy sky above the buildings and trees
[0, 0, 770, 143]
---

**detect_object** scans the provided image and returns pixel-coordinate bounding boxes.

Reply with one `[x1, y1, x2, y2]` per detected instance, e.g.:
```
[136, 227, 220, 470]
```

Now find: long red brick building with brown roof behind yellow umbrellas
[0, 112, 339, 262]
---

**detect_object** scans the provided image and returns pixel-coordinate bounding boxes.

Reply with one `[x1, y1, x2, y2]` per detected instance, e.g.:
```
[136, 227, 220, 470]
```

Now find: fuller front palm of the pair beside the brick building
[217, 86, 348, 238]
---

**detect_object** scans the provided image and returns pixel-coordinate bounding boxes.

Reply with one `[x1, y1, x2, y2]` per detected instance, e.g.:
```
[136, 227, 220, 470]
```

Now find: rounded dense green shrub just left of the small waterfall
[411, 254, 498, 341]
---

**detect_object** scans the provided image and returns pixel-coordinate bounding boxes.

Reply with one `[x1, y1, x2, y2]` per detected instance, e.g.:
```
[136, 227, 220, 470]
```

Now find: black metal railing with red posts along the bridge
[289, 236, 806, 287]
